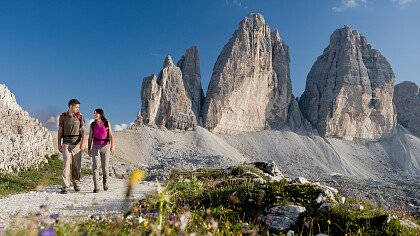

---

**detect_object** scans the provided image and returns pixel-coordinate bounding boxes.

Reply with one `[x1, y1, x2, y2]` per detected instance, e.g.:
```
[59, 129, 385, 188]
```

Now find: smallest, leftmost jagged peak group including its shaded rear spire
[139, 47, 204, 129]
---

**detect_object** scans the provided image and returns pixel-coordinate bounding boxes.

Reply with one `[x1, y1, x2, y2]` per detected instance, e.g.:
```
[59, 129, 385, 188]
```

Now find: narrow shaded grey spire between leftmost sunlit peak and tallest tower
[177, 46, 204, 122]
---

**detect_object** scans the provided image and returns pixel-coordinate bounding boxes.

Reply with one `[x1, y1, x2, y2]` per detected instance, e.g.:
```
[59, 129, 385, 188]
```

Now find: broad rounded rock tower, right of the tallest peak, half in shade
[299, 26, 396, 140]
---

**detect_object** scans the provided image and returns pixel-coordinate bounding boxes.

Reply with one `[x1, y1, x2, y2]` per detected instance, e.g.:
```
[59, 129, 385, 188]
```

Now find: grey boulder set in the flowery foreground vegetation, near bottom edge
[261, 205, 306, 231]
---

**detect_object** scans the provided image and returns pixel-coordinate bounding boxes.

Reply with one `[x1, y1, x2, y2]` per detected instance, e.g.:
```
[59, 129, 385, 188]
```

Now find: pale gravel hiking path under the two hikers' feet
[0, 176, 157, 231]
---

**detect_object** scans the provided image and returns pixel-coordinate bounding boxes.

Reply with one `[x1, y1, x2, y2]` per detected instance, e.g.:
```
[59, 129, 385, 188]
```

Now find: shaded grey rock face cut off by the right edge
[394, 81, 420, 137]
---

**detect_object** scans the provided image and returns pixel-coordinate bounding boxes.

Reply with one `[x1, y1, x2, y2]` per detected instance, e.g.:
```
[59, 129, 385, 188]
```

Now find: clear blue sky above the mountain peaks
[0, 0, 420, 130]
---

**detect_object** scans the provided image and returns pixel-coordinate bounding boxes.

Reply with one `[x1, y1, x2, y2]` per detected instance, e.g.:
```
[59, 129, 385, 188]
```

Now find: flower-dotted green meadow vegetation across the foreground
[4, 167, 420, 235]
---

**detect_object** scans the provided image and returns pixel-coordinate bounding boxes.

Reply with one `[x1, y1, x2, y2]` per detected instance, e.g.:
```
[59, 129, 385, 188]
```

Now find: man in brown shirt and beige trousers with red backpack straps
[58, 99, 86, 194]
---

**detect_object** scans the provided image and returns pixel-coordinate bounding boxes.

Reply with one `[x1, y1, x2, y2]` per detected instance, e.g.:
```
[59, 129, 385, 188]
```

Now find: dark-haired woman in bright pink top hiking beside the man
[88, 108, 115, 193]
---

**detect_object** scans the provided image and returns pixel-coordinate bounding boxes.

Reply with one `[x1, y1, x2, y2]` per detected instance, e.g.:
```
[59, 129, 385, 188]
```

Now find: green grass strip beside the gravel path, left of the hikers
[0, 154, 92, 197]
